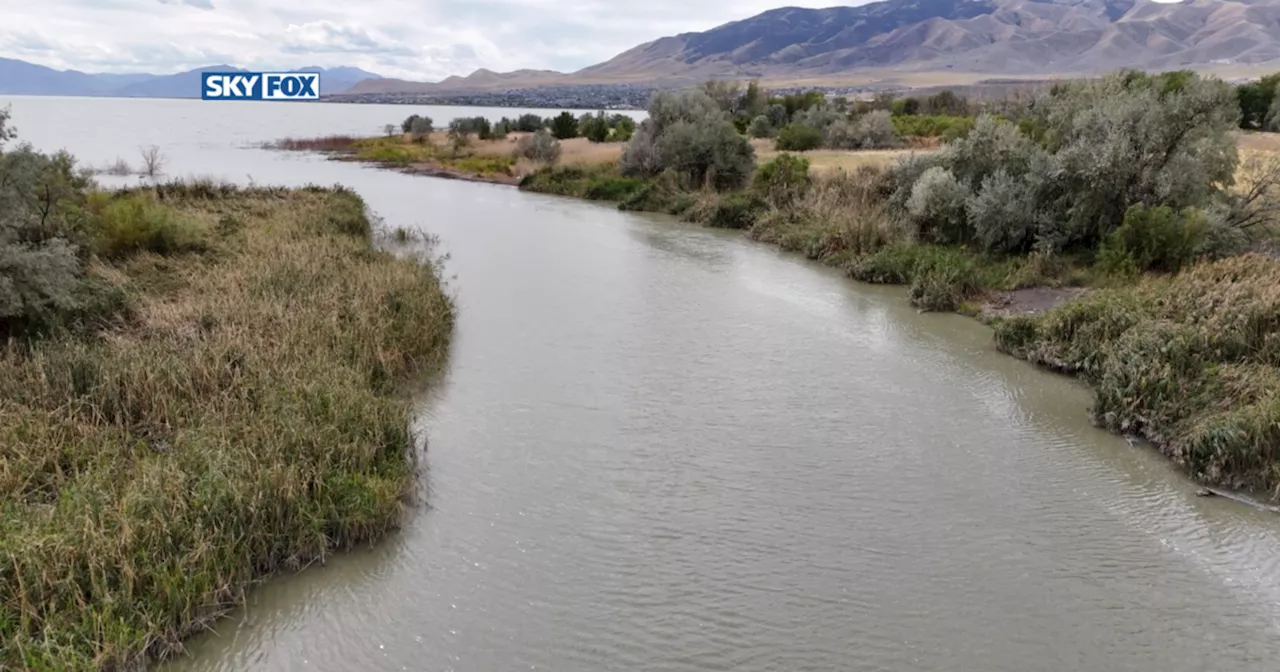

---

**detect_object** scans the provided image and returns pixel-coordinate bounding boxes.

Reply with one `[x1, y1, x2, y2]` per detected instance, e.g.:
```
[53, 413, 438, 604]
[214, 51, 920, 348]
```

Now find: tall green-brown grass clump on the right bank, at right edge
[996, 255, 1280, 498]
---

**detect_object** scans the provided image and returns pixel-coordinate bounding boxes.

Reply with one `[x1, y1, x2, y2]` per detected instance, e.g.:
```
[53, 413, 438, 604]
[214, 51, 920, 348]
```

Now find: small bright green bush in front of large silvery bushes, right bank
[1098, 205, 1208, 275]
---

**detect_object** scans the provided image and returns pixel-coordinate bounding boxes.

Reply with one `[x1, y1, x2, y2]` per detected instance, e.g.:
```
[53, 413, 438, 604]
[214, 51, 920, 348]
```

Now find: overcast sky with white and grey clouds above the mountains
[0, 0, 863, 81]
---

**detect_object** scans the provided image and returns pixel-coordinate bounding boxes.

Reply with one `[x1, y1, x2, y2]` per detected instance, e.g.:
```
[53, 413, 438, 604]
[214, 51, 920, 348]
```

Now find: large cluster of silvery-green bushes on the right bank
[886, 72, 1242, 270]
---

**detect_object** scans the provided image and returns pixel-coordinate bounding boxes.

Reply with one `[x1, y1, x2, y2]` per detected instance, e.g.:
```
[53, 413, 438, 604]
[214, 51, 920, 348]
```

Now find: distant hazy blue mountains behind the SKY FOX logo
[0, 59, 380, 99]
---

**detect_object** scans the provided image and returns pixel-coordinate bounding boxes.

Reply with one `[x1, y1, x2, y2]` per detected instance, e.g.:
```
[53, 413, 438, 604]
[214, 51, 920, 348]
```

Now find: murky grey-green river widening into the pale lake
[0, 96, 1280, 672]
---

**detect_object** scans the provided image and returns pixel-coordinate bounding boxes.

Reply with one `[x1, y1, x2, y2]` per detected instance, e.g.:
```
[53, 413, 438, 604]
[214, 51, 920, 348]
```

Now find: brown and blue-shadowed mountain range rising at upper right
[348, 0, 1280, 93]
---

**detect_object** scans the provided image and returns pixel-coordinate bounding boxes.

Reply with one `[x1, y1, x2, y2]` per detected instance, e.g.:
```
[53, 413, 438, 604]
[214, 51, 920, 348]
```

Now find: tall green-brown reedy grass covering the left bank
[0, 183, 453, 671]
